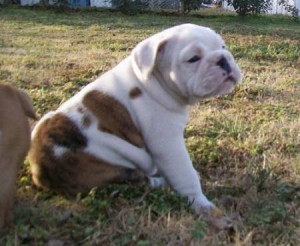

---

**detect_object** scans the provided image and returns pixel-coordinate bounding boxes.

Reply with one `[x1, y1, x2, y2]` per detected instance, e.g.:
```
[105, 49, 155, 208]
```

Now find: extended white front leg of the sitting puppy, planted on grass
[149, 136, 215, 213]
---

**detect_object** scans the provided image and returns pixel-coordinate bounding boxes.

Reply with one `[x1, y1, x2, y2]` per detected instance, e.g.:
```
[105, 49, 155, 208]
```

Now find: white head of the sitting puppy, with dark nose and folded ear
[132, 24, 242, 104]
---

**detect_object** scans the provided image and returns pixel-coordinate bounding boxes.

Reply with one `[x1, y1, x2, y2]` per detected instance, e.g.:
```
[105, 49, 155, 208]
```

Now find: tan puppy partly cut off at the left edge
[0, 85, 36, 233]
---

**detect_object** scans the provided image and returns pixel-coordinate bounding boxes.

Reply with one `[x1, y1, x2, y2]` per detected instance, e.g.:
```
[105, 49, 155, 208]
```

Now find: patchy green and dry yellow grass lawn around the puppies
[0, 7, 300, 246]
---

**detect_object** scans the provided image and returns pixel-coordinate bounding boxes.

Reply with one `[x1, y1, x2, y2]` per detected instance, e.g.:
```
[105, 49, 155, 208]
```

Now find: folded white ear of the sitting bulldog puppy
[132, 36, 168, 81]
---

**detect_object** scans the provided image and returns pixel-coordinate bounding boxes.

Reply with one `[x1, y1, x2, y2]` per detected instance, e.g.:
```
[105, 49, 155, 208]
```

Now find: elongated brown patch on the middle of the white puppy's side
[83, 91, 145, 148]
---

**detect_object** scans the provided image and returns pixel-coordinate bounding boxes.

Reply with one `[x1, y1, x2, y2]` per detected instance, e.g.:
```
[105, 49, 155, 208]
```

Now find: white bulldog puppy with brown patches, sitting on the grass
[29, 24, 241, 212]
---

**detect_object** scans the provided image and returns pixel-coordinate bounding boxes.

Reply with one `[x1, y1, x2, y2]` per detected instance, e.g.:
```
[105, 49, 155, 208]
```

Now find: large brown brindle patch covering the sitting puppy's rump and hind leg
[29, 114, 144, 195]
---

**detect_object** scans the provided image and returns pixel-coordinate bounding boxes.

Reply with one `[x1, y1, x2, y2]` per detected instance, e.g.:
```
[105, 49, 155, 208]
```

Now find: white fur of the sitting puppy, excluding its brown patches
[32, 24, 241, 211]
